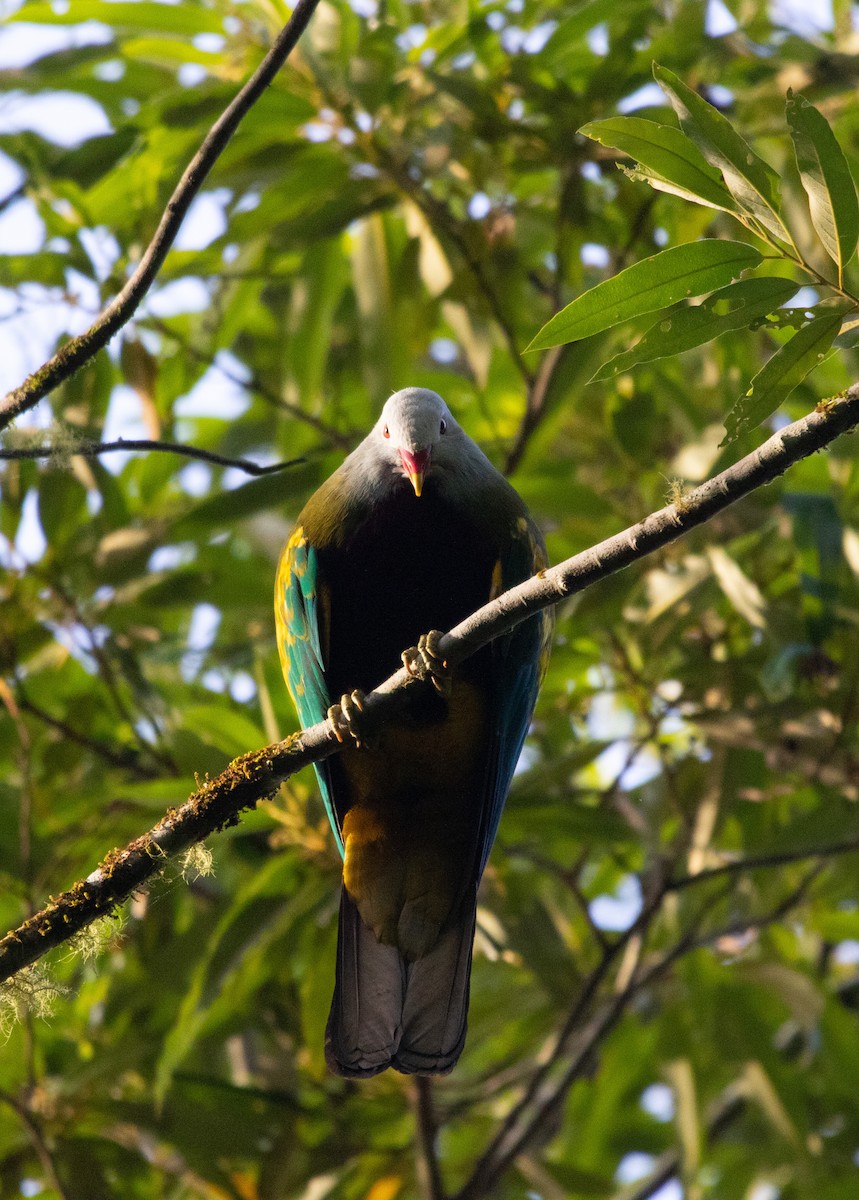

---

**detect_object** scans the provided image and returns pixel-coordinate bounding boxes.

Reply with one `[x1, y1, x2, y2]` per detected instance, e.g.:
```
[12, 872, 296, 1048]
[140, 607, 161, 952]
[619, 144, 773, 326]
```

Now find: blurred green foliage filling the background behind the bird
[0, 0, 859, 1200]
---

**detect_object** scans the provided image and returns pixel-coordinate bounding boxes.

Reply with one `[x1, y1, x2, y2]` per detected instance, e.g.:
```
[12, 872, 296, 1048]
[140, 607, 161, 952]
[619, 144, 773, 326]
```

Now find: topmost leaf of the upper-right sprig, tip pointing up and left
[653, 65, 789, 241]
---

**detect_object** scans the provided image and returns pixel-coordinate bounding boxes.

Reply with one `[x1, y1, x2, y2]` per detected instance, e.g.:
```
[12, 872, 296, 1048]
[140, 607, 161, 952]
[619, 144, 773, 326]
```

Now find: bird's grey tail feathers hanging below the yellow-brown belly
[325, 888, 475, 1079]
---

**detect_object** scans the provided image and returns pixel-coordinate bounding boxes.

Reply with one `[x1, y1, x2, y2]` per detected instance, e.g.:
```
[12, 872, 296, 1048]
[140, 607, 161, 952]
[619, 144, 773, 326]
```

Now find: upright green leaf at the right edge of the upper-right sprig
[785, 91, 859, 283]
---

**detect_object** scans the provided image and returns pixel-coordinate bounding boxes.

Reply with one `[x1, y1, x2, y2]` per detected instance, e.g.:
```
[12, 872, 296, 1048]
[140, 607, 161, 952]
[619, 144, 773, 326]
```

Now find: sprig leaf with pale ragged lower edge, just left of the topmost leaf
[578, 116, 738, 212]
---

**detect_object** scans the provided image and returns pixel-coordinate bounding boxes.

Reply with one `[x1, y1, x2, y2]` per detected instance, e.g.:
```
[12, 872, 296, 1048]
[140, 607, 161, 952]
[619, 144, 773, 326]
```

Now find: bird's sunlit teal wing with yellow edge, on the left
[275, 526, 343, 857]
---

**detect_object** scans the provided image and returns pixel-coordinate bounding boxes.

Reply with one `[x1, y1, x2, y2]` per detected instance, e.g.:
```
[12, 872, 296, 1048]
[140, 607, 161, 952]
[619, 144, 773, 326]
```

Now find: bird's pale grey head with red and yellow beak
[371, 388, 469, 496]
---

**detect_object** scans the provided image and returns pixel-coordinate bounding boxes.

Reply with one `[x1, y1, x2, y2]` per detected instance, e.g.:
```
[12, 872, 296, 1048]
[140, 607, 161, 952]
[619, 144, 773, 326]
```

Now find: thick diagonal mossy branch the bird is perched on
[0, 384, 859, 980]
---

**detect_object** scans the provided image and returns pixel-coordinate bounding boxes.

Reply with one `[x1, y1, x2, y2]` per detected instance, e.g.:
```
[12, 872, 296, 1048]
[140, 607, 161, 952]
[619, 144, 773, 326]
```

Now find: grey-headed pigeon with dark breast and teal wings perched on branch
[275, 388, 552, 1079]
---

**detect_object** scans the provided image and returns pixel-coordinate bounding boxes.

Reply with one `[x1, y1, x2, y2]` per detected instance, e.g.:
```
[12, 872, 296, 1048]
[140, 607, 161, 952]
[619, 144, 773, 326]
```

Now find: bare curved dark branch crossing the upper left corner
[0, 0, 319, 430]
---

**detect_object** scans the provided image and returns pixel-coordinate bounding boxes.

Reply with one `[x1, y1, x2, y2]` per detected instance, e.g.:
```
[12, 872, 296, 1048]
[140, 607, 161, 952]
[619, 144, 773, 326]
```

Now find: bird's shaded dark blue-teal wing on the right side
[480, 517, 553, 874]
